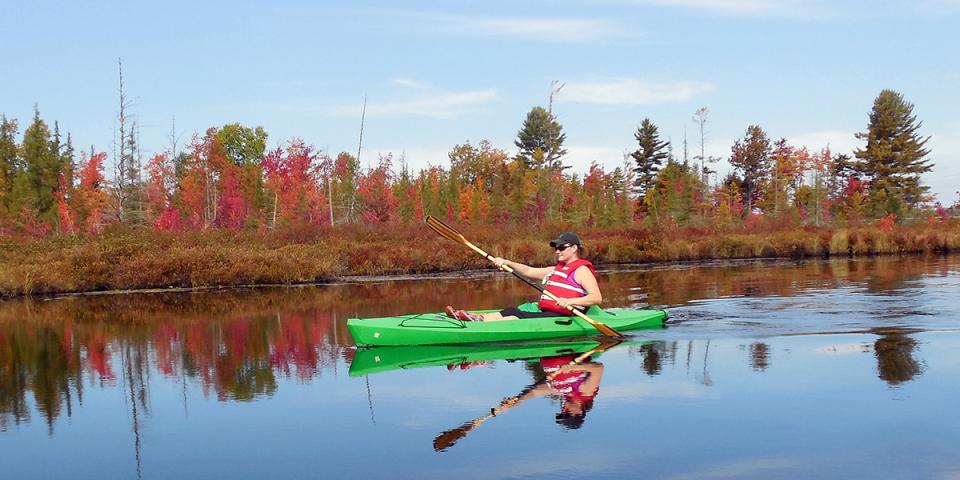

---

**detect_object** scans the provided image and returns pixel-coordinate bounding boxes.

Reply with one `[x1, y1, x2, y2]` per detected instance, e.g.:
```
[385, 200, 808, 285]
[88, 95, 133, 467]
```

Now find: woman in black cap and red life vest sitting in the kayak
[446, 232, 603, 322]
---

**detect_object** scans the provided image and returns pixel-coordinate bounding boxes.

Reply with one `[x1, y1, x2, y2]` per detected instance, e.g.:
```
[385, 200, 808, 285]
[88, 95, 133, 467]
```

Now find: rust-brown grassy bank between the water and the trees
[0, 222, 960, 297]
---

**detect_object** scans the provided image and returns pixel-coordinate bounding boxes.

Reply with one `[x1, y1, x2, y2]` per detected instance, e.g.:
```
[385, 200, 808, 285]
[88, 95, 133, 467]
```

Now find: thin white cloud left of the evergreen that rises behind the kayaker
[327, 89, 497, 119]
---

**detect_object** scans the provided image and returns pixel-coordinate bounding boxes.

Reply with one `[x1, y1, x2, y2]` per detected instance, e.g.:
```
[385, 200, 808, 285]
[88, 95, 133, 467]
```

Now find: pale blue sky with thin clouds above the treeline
[0, 0, 960, 203]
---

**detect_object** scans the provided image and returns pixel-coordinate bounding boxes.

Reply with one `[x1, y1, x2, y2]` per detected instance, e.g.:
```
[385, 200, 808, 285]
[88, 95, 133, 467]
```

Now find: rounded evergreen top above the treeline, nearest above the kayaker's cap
[513, 107, 567, 170]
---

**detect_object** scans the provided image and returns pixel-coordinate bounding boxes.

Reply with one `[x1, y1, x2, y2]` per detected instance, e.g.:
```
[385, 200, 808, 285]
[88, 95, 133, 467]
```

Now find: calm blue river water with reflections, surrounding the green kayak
[0, 257, 960, 479]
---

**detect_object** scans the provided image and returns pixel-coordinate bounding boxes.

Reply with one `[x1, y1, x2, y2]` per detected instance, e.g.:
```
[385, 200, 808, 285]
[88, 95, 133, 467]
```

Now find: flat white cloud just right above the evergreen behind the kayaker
[557, 78, 713, 105]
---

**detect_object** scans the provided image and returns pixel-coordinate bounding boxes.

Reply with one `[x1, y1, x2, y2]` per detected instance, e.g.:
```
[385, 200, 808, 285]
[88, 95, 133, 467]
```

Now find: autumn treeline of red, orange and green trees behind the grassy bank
[0, 90, 957, 236]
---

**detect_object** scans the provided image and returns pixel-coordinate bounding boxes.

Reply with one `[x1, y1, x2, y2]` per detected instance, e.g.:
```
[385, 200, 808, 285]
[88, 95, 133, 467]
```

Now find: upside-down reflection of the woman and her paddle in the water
[433, 342, 619, 452]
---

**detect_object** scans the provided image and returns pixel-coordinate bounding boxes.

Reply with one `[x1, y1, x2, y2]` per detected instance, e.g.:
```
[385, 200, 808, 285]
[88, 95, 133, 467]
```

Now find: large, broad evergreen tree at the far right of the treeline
[854, 90, 932, 216]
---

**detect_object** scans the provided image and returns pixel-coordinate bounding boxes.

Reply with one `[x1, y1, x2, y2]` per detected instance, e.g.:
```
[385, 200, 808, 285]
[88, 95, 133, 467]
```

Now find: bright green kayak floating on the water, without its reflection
[347, 306, 667, 346]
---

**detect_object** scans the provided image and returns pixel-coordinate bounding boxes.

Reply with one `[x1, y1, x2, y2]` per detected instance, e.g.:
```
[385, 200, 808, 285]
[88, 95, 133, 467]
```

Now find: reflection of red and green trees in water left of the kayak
[0, 289, 360, 432]
